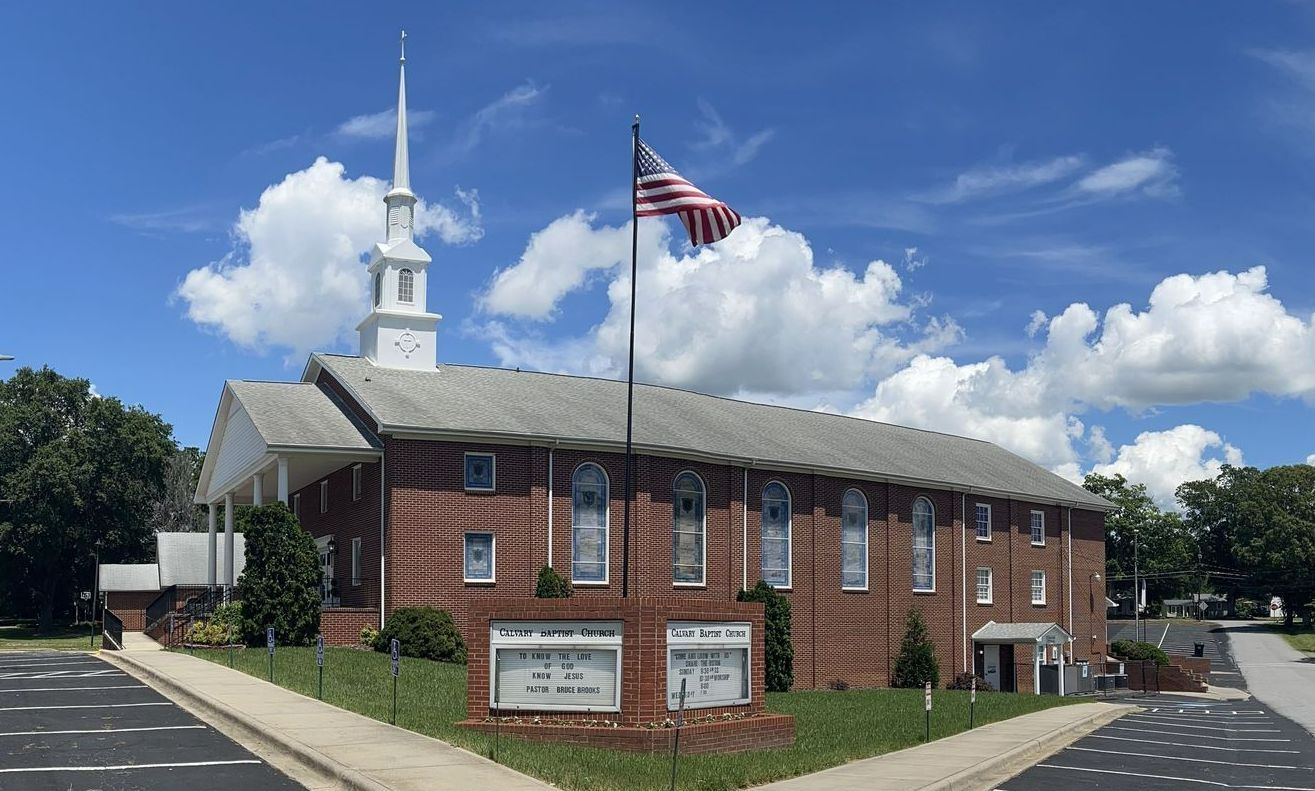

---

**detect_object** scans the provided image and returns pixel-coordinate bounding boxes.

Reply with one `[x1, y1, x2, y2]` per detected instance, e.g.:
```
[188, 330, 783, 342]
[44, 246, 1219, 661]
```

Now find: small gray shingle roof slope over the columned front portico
[229, 380, 381, 451]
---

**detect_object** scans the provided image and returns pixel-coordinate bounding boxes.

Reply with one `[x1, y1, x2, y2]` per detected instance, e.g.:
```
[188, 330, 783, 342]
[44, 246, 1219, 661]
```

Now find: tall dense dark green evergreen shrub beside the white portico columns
[238, 503, 321, 645]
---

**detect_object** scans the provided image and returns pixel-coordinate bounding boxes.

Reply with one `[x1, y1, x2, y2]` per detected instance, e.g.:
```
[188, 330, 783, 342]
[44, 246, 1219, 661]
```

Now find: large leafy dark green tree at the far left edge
[0, 368, 175, 631]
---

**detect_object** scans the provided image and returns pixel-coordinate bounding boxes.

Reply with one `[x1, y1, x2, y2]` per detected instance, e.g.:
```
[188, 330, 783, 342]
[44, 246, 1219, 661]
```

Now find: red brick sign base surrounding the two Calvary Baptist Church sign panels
[458, 597, 794, 753]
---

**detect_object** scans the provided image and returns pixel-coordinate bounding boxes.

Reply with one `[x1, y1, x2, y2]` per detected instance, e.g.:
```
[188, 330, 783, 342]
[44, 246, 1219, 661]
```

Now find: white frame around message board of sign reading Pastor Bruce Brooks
[489, 620, 626, 712]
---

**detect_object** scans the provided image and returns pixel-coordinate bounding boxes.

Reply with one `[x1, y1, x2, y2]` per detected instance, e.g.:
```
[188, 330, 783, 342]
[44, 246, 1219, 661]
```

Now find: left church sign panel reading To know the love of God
[489, 620, 625, 711]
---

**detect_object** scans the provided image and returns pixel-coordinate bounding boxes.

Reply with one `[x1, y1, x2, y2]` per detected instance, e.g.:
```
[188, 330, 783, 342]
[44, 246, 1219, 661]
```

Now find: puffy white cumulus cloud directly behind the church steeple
[176, 156, 483, 355]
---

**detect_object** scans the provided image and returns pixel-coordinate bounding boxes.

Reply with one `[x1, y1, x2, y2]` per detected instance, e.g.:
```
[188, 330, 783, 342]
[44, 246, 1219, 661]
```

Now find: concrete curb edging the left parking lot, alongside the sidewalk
[101, 652, 389, 791]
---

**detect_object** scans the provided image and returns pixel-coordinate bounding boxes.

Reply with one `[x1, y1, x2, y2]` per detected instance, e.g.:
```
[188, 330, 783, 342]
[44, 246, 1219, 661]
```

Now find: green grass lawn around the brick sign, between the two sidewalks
[185, 648, 1073, 791]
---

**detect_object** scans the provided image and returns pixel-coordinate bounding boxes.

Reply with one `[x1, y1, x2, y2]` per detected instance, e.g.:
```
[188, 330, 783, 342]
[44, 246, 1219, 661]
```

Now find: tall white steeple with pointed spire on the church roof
[356, 32, 442, 369]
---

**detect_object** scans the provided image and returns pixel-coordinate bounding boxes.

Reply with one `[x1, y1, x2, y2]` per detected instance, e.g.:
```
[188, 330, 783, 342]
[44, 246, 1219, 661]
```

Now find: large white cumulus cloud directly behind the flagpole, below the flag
[481, 213, 959, 397]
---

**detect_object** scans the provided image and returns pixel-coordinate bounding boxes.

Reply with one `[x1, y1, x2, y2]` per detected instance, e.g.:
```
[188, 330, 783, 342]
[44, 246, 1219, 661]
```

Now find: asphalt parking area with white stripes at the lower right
[998, 695, 1315, 791]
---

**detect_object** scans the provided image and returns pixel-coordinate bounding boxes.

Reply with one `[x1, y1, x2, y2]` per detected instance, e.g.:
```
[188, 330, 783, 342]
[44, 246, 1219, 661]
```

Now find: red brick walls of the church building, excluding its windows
[293, 428, 1106, 690]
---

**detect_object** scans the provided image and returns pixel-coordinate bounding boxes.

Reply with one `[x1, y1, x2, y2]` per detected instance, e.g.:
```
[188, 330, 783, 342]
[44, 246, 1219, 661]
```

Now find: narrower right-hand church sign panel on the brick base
[667, 620, 752, 711]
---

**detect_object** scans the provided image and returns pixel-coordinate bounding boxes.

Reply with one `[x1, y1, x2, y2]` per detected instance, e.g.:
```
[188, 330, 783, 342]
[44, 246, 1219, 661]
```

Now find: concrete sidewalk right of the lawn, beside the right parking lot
[755, 692, 1139, 791]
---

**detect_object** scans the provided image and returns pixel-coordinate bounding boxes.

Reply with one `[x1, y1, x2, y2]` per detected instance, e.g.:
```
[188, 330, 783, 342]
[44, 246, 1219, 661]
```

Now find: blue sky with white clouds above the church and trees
[0, 3, 1315, 501]
